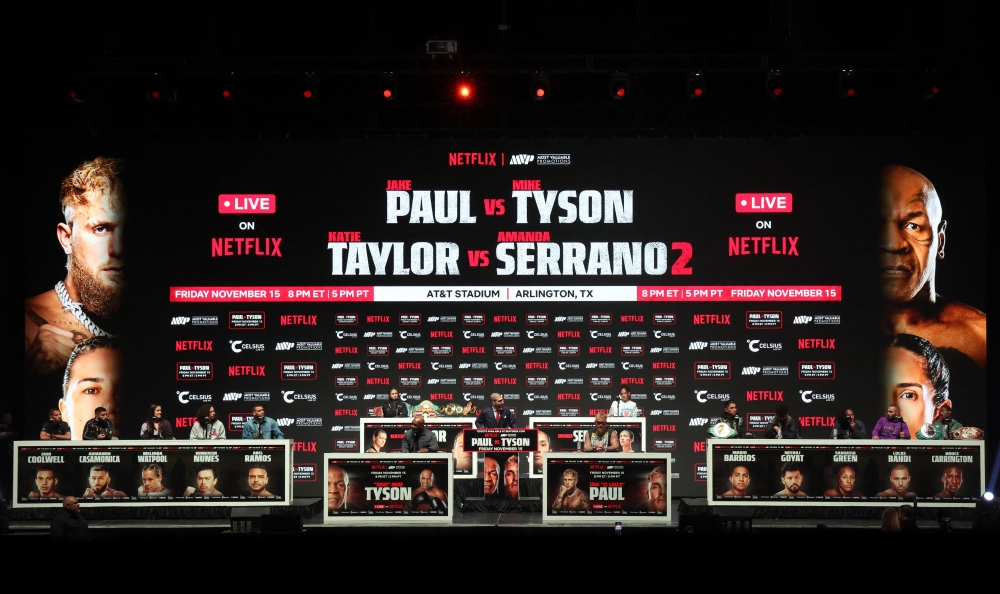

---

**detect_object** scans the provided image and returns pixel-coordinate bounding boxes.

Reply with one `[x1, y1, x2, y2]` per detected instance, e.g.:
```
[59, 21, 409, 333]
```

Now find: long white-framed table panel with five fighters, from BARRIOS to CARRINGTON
[707, 439, 986, 507]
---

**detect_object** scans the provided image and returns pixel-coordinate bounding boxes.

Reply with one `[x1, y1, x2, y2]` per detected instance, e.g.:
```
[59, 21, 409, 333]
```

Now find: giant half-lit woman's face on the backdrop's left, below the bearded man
[59, 336, 121, 440]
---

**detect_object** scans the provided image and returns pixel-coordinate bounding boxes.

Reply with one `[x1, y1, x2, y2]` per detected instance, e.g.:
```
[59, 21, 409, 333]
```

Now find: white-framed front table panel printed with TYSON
[324, 453, 454, 524]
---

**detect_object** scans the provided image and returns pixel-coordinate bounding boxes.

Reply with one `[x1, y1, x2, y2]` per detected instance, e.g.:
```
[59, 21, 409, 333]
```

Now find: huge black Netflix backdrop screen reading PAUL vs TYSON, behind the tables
[23, 139, 986, 496]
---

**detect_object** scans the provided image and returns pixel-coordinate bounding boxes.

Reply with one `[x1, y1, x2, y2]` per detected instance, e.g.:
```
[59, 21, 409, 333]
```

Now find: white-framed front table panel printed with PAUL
[542, 452, 671, 525]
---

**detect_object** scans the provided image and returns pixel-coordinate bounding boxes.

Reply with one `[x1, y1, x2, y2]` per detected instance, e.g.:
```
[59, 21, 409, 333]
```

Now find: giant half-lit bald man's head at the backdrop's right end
[879, 165, 947, 303]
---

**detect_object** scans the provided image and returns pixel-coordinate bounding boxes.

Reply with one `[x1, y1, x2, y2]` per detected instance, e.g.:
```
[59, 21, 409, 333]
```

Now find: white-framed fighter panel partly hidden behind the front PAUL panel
[528, 417, 648, 477]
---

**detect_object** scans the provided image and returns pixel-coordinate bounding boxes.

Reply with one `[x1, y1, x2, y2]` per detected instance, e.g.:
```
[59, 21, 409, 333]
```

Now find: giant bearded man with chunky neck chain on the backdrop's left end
[24, 157, 125, 375]
